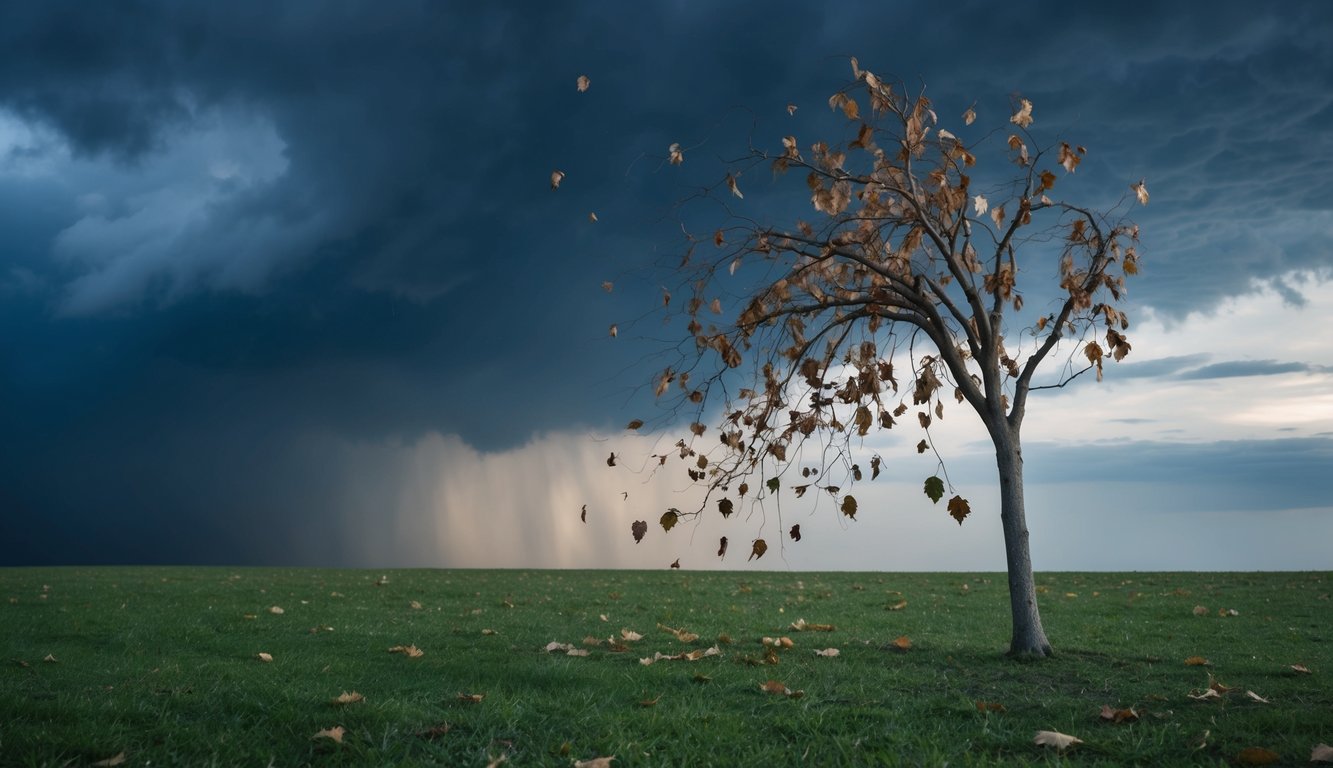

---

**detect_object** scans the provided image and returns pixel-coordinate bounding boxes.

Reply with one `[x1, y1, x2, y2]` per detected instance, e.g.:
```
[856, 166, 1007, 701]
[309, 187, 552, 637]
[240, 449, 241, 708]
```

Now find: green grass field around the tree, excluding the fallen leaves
[0, 568, 1333, 768]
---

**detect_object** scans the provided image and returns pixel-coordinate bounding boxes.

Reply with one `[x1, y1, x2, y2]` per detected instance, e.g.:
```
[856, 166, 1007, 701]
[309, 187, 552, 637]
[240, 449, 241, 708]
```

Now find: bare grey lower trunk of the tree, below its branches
[992, 424, 1052, 657]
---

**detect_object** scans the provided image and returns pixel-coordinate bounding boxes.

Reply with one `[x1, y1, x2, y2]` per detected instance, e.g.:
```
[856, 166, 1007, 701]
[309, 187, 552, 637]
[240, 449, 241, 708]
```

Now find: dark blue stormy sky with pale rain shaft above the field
[0, 0, 1333, 571]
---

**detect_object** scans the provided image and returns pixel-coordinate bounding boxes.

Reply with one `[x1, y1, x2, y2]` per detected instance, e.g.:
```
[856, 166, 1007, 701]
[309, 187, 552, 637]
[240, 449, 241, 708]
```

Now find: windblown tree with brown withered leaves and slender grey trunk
[632, 59, 1148, 656]
